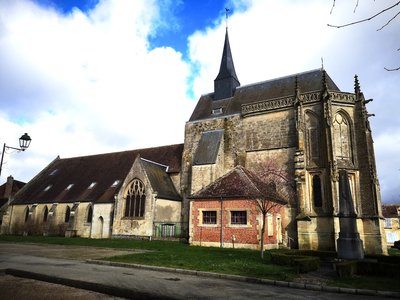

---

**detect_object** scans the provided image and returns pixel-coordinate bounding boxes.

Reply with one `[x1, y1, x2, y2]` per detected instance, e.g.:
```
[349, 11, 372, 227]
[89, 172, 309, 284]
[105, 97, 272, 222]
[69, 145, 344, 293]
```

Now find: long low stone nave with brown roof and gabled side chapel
[1, 144, 183, 238]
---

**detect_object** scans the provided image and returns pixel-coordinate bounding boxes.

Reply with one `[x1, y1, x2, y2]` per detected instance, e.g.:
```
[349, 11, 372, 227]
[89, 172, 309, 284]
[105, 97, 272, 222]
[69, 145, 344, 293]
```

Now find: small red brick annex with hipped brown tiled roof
[189, 166, 287, 249]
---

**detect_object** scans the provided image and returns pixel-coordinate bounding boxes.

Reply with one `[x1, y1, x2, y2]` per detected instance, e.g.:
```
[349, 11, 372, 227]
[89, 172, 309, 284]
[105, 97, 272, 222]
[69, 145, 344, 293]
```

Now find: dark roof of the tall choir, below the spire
[189, 69, 340, 121]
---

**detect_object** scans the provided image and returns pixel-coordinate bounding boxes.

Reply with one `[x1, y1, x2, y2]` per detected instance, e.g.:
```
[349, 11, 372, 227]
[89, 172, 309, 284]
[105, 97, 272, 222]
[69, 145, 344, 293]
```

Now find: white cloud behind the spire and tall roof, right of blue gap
[190, 0, 400, 202]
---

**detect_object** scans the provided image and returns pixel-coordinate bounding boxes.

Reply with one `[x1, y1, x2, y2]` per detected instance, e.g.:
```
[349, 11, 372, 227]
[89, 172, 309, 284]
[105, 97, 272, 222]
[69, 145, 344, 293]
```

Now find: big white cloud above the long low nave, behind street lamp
[0, 0, 194, 180]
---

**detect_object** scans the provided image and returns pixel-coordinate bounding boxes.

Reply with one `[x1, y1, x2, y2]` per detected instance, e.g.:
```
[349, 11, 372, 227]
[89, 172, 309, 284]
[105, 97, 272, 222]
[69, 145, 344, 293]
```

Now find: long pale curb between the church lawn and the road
[86, 259, 400, 298]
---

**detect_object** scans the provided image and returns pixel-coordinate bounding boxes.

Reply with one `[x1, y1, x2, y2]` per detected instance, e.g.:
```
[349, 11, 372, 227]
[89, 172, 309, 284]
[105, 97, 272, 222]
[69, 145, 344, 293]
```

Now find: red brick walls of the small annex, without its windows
[191, 200, 283, 246]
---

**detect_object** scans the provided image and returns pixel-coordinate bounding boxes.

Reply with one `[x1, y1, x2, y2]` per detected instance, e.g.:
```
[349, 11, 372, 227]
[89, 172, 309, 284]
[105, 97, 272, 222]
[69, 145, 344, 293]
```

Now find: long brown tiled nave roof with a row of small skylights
[13, 144, 183, 204]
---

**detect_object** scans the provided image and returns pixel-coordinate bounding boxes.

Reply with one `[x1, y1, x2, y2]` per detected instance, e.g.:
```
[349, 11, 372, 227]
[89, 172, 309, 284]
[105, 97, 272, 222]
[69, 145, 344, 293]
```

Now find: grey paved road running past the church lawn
[0, 243, 396, 299]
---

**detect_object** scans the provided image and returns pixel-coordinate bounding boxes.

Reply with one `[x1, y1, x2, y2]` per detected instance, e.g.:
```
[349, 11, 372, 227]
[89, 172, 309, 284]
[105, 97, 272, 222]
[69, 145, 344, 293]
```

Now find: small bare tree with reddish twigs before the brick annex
[253, 158, 295, 258]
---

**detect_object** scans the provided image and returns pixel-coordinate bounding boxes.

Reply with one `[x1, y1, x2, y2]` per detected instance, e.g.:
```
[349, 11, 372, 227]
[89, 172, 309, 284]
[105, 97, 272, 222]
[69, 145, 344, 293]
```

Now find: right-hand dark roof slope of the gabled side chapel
[140, 158, 182, 200]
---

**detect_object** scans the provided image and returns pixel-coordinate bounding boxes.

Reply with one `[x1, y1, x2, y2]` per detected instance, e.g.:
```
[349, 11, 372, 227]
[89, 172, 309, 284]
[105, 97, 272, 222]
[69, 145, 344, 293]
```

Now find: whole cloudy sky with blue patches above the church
[0, 0, 400, 203]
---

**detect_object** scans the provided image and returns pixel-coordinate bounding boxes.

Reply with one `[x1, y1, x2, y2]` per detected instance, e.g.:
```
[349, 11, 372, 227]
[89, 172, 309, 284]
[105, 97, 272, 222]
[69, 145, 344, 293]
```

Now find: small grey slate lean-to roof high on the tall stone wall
[193, 130, 224, 165]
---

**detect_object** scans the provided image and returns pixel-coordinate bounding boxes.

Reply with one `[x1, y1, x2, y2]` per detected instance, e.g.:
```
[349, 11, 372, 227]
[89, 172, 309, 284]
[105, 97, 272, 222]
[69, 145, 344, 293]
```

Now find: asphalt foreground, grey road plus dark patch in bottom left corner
[0, 243, 396, 299]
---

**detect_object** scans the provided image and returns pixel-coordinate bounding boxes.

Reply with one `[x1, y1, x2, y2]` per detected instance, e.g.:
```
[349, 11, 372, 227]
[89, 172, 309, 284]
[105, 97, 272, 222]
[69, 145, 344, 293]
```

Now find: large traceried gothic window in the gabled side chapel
[125, 178, 146, 217]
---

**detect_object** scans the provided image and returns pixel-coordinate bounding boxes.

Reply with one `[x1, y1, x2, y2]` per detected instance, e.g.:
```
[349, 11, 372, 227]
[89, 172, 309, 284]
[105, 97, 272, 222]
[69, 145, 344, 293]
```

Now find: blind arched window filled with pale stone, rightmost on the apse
[333, 113, 351, 160]
